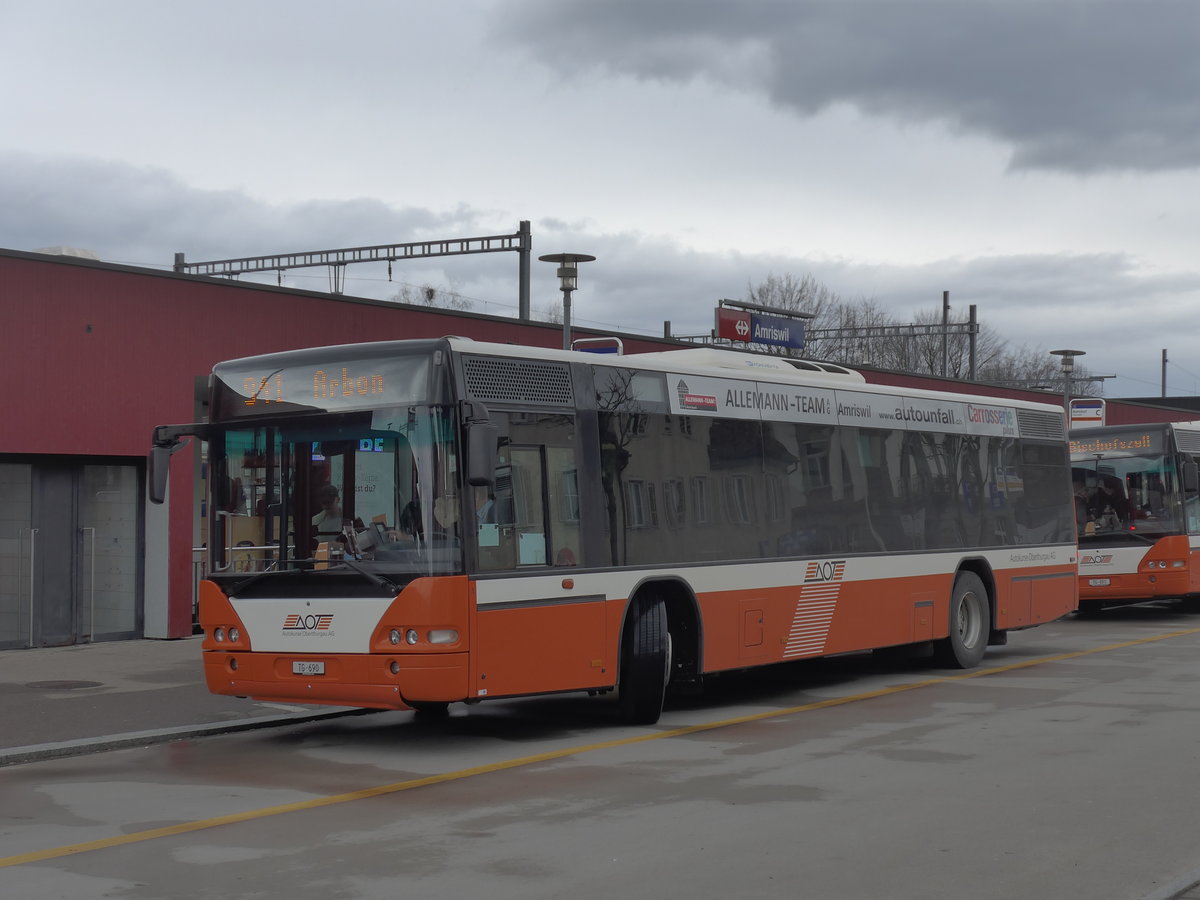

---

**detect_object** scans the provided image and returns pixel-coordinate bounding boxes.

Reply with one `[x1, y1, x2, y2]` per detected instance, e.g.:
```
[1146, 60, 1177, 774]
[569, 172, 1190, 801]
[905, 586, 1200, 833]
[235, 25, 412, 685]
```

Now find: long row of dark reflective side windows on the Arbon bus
[590, 364, 1074, 564]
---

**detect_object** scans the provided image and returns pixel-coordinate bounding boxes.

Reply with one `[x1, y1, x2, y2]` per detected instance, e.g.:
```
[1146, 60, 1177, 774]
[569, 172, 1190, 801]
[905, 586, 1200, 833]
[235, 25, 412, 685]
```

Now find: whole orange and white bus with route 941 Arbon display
[151, 337, 1078, 722]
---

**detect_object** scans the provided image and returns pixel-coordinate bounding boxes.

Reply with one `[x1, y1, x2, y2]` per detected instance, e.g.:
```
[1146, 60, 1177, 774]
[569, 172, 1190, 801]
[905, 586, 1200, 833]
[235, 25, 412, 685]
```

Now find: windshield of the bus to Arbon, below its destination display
[209, 406, 463, 583]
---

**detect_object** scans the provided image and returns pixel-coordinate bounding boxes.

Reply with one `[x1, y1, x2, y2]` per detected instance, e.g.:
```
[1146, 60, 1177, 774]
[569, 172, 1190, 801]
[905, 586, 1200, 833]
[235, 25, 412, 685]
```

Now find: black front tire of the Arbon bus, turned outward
[618, 593, 670, 725]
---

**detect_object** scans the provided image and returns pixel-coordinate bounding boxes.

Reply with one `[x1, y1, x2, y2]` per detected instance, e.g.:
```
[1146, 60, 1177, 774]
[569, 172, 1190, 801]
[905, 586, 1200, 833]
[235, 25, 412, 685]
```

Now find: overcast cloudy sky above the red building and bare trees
[0, 0, 1200, 396]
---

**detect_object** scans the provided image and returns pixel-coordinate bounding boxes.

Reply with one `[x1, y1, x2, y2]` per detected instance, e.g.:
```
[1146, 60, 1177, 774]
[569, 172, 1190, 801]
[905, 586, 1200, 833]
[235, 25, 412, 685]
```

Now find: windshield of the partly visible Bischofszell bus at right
[1072, 452, 1184, 539]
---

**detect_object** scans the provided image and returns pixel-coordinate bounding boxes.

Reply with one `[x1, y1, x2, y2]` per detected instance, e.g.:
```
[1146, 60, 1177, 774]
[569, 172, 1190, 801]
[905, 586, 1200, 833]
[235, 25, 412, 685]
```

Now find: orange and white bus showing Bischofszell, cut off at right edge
[1070, 421, 1200, 612]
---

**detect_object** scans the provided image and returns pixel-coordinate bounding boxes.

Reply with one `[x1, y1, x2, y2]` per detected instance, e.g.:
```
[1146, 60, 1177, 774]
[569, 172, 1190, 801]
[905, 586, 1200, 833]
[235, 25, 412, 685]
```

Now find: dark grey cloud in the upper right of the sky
[494, 0, 1200, 173]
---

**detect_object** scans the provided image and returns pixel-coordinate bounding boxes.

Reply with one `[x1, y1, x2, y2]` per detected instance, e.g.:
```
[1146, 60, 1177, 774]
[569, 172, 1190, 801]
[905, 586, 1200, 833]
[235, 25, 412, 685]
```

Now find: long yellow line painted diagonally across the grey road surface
[0, 628, 1200, 869]
